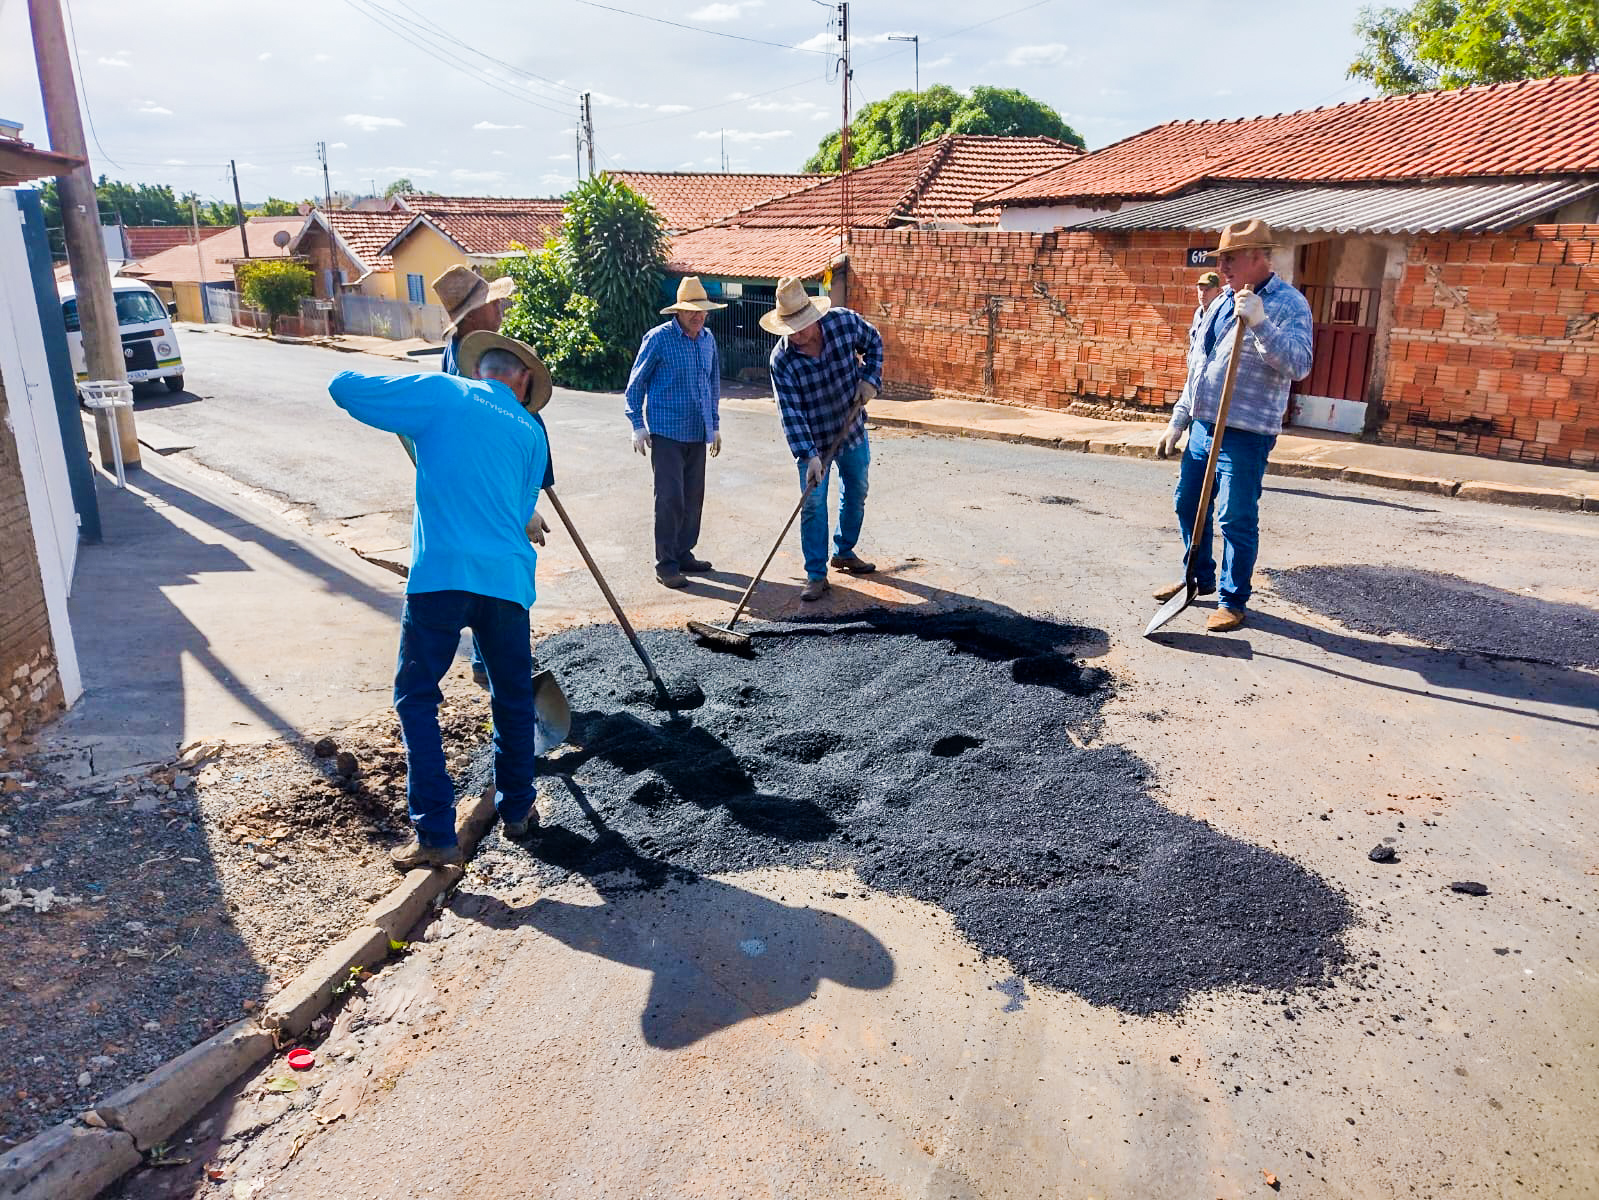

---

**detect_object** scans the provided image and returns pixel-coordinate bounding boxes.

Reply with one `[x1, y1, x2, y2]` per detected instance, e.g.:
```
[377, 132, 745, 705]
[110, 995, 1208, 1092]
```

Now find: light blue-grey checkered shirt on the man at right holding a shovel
[1172, 275, 1311, 435]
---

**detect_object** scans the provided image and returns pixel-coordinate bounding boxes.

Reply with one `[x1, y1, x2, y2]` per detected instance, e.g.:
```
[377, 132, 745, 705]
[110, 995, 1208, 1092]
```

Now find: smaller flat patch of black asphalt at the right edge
[1270, 563, 1599, 669]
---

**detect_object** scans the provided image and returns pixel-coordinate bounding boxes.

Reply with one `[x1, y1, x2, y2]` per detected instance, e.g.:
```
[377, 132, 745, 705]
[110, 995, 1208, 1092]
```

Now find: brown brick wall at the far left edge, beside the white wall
[0, 371, 64, 749]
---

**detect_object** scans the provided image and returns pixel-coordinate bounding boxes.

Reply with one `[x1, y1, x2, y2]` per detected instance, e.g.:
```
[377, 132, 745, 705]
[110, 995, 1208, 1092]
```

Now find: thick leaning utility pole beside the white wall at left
[27, 0, 139, 469]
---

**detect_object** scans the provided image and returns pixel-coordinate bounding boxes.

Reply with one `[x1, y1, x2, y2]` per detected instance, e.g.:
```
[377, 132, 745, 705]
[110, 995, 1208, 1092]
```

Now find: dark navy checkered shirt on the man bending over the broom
[771, 309, 883, 461]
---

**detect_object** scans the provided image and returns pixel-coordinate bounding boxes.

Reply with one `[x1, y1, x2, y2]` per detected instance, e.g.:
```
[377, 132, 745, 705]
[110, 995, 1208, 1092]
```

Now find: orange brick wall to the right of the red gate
[1377, 226, 1599, 467]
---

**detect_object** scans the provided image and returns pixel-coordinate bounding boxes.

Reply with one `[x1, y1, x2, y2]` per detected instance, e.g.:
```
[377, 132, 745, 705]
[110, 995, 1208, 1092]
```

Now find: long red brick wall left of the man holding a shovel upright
[849, 230, 1194, 418]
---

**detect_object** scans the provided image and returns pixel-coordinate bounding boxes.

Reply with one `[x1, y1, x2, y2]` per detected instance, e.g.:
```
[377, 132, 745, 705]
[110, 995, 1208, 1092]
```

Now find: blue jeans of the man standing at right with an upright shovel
[1177, 421, 1278, 613]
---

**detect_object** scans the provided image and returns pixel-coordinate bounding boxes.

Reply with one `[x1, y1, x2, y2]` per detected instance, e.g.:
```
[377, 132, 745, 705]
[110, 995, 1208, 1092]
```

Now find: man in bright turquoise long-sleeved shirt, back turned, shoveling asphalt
[328, 331, 550, 870]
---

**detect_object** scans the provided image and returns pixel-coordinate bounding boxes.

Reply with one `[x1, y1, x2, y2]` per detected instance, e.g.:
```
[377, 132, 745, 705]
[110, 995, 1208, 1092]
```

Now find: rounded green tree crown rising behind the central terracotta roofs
[804, 83, 1083, 171]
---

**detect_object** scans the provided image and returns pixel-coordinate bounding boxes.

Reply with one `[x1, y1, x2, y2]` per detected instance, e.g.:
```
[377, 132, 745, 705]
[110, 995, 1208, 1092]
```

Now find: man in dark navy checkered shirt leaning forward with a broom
[761, 278, 883, 600]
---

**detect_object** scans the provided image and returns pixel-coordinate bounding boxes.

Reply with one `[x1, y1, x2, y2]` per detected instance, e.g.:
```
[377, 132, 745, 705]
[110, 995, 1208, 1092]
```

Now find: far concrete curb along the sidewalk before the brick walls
[868, 411, 1599, 512]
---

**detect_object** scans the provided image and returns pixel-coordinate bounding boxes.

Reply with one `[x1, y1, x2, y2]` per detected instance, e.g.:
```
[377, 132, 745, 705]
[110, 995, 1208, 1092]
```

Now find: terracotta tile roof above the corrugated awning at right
[982, 74, 1599, 206]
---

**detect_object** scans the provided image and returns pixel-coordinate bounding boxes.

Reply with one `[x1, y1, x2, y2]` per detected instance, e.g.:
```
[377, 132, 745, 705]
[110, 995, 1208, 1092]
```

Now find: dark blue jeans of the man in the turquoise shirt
[395, 592, 537, 846]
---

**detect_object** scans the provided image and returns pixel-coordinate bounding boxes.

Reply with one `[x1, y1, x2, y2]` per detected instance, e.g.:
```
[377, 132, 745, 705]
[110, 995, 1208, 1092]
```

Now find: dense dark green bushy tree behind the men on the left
[502, 176, 665, 387]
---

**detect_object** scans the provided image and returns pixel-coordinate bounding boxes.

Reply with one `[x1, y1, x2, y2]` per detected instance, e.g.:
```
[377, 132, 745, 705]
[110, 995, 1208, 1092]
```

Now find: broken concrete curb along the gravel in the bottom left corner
[0, 784, 496, 1200]
